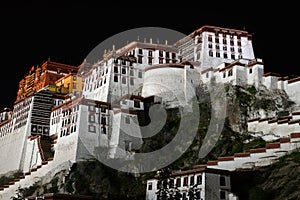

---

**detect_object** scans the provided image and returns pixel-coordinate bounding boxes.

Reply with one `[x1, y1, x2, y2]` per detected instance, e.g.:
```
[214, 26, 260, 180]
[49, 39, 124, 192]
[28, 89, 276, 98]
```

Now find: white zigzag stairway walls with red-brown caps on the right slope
[204, 112, 300, 171]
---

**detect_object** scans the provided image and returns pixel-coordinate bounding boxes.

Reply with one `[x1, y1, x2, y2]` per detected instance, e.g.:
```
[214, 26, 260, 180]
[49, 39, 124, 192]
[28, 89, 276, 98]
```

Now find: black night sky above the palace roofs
[0, 1, 300, 109]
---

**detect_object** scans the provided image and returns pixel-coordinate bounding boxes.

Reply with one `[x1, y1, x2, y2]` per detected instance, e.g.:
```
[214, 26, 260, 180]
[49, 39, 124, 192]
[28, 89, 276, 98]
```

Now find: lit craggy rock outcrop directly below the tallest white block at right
[225, 84, 295, 133]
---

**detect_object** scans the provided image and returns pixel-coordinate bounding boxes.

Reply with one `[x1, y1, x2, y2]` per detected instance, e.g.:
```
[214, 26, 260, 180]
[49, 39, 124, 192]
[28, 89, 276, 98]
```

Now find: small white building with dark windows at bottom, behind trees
[146, 166, 237, 200]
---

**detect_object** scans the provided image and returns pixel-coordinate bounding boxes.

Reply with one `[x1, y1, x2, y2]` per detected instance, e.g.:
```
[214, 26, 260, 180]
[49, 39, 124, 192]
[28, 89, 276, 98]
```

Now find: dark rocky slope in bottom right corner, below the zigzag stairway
[231, 152, 300, 200]
